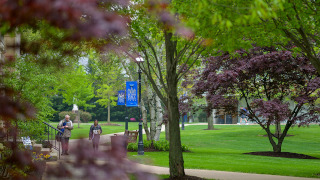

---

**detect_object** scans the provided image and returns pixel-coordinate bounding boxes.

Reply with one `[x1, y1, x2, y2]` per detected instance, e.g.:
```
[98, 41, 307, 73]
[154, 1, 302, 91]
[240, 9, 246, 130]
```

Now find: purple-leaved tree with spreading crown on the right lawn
[193, 47, 320, 152]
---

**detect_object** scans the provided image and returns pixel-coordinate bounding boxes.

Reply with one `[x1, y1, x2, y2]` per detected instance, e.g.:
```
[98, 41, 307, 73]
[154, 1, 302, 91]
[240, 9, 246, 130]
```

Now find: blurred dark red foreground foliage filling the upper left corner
[0, 0, 128, 126]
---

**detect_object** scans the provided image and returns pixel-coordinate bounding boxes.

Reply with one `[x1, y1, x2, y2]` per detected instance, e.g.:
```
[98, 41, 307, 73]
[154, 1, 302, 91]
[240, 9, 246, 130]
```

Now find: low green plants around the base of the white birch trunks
[127, 140, 190, 152]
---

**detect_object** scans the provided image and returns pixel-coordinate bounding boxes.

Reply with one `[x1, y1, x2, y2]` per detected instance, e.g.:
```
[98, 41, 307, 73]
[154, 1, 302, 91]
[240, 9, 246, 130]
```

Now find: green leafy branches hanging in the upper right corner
[248, 0, 320, 72]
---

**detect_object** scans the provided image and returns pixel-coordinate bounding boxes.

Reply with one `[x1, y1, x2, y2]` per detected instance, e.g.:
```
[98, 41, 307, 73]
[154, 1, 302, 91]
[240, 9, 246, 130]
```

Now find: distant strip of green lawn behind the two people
[50, 121, 139, 139]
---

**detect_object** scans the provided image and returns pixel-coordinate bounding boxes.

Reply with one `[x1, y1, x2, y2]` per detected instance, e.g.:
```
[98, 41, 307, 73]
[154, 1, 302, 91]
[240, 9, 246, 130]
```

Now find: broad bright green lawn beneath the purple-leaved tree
[129, 125, 320, 178]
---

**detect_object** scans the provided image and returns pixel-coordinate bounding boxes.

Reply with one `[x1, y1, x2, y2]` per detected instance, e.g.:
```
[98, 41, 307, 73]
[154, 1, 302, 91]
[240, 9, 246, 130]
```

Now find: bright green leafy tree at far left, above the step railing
[4, 55, 58, 140]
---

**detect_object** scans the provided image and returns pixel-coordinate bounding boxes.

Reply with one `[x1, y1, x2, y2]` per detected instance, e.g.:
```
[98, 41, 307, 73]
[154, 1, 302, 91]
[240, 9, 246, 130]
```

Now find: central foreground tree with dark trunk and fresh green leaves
[122, 1, 208, 178]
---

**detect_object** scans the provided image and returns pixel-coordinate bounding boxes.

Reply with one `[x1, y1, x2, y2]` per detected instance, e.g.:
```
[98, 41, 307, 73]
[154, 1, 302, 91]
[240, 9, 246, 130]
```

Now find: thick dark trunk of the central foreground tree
[164, 31, 185, 178]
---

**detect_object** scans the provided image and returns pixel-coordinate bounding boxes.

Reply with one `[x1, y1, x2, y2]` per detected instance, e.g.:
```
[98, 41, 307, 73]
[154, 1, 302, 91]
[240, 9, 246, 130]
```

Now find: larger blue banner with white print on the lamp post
[126, 81, 138, 107]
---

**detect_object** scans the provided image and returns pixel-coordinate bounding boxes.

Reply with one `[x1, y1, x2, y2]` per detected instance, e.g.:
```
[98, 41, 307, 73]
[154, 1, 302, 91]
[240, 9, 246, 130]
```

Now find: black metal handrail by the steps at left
[43, 122, 63, 159]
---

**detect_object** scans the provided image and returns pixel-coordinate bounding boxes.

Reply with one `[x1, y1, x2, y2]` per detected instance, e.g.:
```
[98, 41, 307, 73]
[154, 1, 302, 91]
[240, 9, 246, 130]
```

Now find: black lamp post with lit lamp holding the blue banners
[136, 57, 144, 155]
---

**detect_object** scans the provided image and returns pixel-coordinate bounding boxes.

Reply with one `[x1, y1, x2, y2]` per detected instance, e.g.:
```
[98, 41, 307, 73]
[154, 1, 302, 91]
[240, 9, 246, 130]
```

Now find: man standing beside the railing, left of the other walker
[57, 115, 73, 155]
